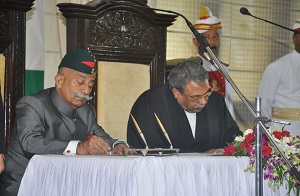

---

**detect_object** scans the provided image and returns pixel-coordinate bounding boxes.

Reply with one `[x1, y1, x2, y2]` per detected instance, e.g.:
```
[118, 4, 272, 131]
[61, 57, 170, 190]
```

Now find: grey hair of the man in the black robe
[168, 60, 208, 93]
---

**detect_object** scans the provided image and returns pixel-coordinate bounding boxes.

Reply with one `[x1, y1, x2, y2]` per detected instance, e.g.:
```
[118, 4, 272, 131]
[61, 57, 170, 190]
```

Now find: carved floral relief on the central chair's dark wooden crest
[88, 11, 156, 53]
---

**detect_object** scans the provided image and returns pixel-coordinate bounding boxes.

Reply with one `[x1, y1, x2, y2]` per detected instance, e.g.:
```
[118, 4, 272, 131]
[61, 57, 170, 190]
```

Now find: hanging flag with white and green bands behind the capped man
[25, 0, 45, 95]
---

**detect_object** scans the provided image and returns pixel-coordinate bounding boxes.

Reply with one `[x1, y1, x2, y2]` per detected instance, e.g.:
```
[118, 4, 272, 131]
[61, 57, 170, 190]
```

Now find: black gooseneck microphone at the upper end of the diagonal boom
[110, 0, 214, 64]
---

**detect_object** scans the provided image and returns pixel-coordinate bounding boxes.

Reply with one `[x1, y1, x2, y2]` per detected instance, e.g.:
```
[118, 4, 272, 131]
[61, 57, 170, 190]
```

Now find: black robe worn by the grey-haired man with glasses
[127, 84, 242, 152]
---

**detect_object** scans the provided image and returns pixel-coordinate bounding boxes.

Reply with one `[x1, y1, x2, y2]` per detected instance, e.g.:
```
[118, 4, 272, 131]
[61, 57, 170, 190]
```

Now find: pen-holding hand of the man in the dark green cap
[76, 135, 111, 155]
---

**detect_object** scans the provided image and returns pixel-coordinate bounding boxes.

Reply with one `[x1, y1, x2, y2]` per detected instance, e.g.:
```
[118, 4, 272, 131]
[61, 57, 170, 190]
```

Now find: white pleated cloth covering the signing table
[18, 154, 293, 196]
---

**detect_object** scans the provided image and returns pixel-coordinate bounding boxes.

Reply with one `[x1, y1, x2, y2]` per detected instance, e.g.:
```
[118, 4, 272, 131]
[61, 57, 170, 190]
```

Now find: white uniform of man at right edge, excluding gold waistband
[258, 50, 300, 136]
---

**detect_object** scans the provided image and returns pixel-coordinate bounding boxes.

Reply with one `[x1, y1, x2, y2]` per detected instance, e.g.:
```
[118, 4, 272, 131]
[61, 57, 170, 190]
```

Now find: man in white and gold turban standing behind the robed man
[193, 4, 234, 118]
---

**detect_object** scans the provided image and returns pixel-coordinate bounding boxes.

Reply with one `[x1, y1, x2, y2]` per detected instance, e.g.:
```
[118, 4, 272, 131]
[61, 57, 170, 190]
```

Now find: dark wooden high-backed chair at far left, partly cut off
[0, 0, 34, 152]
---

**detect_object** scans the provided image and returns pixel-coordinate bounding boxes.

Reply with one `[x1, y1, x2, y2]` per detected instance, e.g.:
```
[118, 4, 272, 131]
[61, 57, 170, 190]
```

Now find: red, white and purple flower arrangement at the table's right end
[224, 128, 300, 194]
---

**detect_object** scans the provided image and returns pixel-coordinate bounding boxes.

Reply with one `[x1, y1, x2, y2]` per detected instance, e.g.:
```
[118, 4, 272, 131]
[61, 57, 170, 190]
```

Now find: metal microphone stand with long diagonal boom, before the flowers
[111, 3, 300, 195]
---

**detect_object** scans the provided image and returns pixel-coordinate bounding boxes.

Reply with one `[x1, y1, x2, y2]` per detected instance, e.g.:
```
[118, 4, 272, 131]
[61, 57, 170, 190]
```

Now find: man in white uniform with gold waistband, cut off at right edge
[258, 18, 300, 136]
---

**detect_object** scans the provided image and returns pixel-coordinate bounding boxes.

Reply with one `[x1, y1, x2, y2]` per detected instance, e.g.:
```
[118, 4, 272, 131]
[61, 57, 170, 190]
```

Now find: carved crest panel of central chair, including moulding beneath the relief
[85, 10, 158, 64]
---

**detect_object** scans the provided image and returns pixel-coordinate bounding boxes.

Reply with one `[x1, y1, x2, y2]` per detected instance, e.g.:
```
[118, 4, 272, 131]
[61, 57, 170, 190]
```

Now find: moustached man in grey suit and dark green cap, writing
[0, 50, 128, 196]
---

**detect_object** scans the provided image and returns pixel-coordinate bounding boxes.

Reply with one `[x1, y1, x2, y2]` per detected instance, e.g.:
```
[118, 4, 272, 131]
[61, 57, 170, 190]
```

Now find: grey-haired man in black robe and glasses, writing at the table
[127, 61, 242, 153]
